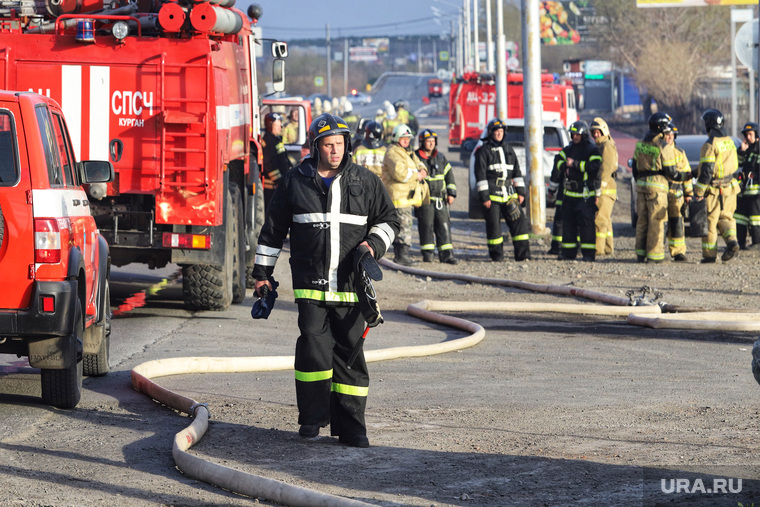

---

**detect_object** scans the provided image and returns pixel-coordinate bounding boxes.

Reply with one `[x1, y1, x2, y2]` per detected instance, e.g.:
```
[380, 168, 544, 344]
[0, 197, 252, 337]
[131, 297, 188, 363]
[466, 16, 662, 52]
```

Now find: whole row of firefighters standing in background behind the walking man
[263, 101, 760, 266]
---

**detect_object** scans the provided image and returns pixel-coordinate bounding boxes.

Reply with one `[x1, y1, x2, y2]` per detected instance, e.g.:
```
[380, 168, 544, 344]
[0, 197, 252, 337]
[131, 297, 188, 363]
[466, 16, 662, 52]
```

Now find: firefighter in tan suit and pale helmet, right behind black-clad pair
[590, 118, 618, 255]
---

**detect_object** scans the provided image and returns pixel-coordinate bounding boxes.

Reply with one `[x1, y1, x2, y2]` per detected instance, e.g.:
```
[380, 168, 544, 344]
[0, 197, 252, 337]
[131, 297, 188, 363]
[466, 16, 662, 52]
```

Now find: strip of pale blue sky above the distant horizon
[240, 0, 464, 40]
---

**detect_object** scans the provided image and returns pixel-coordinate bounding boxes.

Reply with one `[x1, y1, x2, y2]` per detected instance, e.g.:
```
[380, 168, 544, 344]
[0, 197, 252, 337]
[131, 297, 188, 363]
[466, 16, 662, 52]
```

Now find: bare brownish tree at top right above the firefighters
[594, 0, 730, 130]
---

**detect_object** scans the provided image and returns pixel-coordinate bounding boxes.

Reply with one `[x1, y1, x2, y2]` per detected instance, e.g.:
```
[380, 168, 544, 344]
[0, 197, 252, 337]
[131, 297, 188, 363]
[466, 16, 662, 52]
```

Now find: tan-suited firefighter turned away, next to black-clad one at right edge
[694, 109, 739, 263]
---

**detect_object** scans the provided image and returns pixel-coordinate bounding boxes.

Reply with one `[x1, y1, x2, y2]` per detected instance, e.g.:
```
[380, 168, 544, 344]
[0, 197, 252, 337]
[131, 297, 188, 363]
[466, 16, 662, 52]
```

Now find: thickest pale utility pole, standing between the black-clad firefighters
[522, 0, 548, 235]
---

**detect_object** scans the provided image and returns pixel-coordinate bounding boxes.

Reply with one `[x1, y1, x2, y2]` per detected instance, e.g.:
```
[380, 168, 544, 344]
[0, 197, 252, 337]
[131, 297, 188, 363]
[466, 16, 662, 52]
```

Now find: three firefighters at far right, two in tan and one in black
[632, 109, 760, 264]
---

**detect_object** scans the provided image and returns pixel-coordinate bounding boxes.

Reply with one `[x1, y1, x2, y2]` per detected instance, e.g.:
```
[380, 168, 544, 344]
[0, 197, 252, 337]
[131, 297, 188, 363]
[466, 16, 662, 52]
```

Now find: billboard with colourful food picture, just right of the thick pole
[538, 0, 595, 46]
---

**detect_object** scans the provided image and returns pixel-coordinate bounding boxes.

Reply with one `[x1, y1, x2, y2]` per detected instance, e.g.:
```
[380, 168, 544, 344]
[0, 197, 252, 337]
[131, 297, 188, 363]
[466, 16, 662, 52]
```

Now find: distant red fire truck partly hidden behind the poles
[449, 72, 578, 151]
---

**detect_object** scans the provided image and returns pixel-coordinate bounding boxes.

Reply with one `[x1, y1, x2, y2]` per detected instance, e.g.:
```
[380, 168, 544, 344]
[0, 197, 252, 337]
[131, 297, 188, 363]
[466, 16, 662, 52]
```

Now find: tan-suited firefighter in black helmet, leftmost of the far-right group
[631, 113, 685, 263]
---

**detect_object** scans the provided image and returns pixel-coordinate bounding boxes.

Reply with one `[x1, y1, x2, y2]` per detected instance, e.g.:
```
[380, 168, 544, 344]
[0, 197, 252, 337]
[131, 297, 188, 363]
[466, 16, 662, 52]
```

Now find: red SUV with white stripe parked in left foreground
[0, 91, 114, 408]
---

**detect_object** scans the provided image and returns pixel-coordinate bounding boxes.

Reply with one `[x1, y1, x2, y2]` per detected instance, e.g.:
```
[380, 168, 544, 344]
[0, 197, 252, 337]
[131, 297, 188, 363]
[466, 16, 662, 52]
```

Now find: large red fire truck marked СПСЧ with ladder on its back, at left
[0, 0, 287, 310]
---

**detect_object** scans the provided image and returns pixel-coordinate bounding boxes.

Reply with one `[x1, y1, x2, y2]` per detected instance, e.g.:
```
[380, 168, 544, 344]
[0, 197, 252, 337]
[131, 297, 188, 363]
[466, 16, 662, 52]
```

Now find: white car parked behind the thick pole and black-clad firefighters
[470, 118, 570, 222]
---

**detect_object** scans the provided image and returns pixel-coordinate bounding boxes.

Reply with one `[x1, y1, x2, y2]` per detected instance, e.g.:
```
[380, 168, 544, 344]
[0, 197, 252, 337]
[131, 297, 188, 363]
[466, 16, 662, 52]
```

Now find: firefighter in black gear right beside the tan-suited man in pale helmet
[417, 129, 459, 264]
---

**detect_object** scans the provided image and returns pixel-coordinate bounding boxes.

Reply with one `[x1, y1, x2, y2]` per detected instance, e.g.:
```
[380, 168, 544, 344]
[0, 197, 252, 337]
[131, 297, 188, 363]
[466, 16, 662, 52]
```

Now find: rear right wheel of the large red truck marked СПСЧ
[182, 192, 237, 311]
